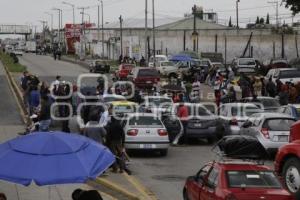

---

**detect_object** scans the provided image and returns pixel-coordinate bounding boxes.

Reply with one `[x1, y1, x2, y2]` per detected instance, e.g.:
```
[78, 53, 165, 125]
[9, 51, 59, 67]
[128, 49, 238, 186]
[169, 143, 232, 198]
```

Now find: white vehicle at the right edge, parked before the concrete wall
[265, 68, 300, 84]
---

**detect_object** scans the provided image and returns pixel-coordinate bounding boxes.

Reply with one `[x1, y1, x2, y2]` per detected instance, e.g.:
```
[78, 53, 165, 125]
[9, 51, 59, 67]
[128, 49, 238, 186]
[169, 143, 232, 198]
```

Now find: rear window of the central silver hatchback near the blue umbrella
[129, 116, 163, 127]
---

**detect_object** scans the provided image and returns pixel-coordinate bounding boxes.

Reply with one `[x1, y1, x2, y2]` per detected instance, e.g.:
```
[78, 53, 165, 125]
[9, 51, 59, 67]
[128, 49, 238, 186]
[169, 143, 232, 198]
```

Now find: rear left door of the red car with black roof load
[200, 167, 219, 200]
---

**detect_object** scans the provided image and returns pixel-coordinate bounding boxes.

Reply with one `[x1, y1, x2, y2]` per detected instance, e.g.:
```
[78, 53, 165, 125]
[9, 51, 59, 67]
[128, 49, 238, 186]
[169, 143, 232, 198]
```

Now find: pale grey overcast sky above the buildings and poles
[0, 0, 300, 32]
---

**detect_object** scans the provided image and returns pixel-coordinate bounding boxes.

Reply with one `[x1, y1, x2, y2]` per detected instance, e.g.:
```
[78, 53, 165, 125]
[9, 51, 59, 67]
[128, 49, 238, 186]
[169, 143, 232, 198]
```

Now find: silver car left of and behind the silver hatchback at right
[219, 103, 263, 135]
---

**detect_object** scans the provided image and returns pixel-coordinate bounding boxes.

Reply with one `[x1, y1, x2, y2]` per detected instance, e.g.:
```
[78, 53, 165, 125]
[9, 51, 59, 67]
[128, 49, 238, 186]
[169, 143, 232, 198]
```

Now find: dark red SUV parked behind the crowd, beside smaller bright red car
[128, 67, 160, 88]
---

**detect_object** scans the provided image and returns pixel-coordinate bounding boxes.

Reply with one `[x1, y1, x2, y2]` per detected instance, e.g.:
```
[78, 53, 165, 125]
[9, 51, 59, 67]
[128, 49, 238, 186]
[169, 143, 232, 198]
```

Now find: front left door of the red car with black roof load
[187, 165, 211, 200]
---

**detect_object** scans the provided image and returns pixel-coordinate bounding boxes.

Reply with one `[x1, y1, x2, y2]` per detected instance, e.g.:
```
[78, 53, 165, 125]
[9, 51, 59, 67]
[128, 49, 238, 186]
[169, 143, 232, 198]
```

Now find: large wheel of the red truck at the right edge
[283, 158, 300, 199]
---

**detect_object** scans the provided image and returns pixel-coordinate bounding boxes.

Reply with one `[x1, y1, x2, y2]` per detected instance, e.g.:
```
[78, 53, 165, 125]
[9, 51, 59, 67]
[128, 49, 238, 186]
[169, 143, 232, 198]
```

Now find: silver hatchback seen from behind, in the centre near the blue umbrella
[122, 113, 170, 156]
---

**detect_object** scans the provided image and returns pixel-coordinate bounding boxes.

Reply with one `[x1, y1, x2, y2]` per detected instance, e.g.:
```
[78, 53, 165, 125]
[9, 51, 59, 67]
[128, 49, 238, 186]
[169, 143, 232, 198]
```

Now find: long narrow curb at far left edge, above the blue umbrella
[0, 60, 30, 124]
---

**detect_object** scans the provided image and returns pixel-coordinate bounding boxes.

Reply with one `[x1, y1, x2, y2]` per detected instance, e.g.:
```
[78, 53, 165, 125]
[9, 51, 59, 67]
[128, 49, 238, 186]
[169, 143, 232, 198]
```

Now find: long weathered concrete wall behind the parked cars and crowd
[84, 29, 300, 62]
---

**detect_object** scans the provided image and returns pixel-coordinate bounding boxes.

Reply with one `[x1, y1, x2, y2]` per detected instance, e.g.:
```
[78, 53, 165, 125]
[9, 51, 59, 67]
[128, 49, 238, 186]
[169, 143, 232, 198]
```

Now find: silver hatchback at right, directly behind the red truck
[240, 113, 296, 152]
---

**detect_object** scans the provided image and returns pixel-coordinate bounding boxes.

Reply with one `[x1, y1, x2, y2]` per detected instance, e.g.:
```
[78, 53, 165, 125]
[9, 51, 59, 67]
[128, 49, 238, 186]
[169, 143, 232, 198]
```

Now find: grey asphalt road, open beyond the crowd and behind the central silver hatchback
[16, 54, 223, 200]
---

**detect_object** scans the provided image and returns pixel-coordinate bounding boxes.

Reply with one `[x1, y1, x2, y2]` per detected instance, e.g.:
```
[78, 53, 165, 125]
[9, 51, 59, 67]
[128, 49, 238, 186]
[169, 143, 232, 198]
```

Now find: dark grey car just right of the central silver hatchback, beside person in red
[174, 104, 223, 143]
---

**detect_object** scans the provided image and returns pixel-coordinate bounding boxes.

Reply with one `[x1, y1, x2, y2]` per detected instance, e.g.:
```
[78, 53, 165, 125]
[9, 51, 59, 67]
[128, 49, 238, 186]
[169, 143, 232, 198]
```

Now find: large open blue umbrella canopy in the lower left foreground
[0, 132, 115, 186]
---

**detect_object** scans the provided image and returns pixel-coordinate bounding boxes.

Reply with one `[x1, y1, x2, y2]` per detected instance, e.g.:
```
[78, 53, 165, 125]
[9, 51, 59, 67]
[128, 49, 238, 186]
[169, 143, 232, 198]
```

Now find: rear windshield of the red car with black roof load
[226, 170, 281, 189]
